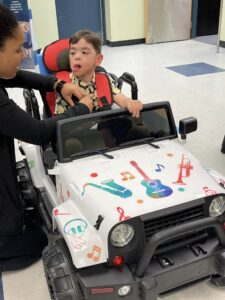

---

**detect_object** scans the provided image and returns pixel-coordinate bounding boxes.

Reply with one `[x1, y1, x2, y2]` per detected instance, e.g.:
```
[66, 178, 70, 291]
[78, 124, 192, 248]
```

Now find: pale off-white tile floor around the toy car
[0, 36, 225, 300]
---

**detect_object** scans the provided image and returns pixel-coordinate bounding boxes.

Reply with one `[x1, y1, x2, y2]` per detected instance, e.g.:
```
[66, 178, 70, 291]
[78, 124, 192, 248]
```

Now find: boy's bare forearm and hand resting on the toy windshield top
[114, 93, 143, 118]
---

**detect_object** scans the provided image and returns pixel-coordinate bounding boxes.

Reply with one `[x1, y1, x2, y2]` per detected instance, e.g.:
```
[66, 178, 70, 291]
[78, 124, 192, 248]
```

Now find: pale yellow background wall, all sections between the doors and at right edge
[23, 0, 225, 49]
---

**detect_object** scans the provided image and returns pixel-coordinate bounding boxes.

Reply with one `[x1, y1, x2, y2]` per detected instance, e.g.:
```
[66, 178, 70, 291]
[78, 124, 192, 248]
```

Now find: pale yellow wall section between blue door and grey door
[104, 0, 145, 42]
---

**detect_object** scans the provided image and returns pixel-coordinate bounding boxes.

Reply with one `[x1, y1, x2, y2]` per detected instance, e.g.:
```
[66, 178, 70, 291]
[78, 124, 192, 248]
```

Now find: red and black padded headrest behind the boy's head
[43, 39, 70, 72]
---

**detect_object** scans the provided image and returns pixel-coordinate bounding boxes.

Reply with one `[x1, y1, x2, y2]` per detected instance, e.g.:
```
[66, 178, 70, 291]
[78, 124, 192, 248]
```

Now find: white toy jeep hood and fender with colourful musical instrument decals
[55, 141, 224, 267]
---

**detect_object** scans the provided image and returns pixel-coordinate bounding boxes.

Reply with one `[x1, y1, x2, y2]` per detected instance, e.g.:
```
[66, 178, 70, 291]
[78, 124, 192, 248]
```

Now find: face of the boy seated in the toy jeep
[69, 38, 103, 83]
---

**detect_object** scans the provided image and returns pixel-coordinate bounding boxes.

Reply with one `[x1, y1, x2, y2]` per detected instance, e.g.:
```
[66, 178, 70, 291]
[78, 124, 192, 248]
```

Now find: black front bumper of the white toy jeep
[78, 218, 225, 300]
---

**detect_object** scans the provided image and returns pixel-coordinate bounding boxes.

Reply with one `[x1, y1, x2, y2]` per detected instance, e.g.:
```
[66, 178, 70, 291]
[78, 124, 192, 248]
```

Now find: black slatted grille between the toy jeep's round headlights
[144, 205, 208, 253]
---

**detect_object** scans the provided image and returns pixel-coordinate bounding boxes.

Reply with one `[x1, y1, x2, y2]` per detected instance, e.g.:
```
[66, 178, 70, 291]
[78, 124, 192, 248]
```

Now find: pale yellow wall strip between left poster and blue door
[28, 0, 58, 49]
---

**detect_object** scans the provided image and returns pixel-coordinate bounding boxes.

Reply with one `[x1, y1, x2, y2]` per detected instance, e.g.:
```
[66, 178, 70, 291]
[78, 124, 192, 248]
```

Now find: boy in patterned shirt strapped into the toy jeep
[55, 30, 143, 117]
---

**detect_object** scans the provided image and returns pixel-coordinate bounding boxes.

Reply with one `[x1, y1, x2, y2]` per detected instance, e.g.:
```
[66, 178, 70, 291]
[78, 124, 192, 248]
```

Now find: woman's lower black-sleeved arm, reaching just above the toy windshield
[0, 90, 90, 145]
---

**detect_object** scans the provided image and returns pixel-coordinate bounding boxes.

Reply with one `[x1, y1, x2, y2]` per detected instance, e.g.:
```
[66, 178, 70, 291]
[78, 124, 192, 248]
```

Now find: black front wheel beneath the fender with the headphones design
[42, 239, 84, 300]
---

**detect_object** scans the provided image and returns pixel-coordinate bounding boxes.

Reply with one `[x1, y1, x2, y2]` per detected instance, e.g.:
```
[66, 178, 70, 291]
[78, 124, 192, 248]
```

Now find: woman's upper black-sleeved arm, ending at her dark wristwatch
[0, 70, 57, 92]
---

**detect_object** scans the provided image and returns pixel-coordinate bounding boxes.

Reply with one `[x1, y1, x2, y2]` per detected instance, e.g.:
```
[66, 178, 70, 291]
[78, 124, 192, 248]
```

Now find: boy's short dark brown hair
[69, 29, 102, 54]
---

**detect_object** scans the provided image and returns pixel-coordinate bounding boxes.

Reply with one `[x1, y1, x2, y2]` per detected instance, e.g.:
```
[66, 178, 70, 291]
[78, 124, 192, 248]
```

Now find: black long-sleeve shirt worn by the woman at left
[0, 71, 89, 235]
